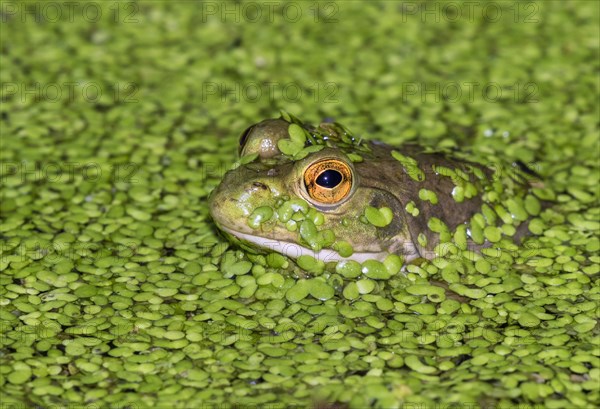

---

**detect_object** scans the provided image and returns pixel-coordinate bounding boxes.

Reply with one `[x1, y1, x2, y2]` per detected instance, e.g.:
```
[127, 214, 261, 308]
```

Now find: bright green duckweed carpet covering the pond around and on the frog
[0, 2, 600, 409]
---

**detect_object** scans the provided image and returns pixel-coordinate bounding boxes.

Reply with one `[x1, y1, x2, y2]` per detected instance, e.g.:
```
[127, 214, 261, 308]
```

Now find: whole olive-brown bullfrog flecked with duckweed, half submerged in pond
[210, 113, 541, 270]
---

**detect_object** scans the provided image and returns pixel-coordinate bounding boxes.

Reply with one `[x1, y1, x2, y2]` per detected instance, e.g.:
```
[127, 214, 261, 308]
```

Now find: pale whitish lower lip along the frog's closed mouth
[220, 225, 390, 263]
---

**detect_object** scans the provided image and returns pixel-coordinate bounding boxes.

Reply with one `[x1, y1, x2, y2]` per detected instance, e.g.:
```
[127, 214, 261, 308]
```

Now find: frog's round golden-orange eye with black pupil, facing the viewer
[304, 159, 352, 204]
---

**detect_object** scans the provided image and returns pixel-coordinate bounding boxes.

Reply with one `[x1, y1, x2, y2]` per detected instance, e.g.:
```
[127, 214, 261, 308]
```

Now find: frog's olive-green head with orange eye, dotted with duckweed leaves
[210, 118, 416, 262]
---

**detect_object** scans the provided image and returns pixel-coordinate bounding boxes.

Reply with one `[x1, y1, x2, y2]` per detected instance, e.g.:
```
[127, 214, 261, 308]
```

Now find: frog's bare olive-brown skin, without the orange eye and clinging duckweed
[210, 118, 528, 263]
